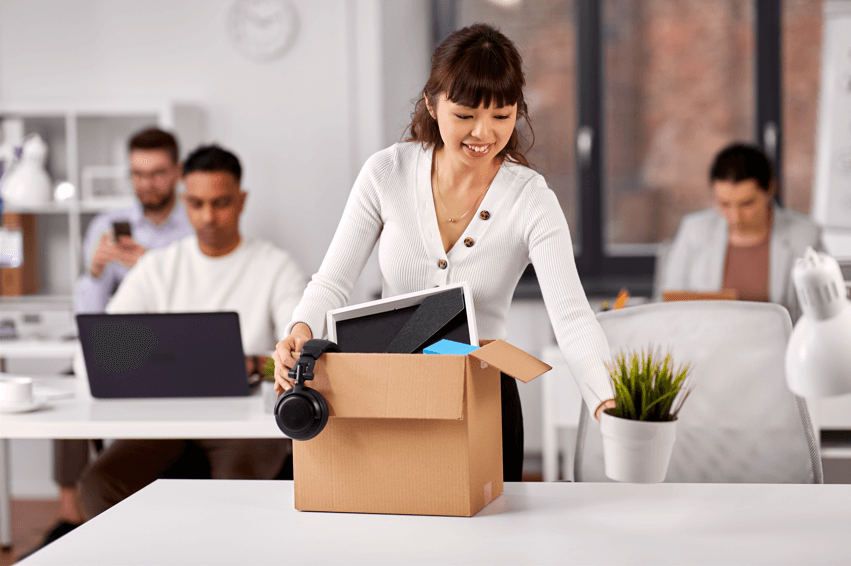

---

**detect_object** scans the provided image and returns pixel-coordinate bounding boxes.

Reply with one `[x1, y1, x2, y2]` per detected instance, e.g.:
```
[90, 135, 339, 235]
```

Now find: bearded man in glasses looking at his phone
[34, 128, 194, 545]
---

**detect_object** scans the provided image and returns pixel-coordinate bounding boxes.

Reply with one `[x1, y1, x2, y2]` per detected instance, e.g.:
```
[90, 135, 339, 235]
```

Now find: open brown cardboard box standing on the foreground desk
[293, 340, 550, 516]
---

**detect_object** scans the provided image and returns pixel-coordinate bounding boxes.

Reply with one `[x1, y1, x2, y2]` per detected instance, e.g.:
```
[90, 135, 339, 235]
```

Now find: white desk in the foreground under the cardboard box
[13, 480, 851, 566]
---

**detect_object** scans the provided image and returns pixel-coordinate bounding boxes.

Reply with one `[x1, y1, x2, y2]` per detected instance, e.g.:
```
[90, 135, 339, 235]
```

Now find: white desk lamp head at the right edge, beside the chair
[786, 248, 851, 397]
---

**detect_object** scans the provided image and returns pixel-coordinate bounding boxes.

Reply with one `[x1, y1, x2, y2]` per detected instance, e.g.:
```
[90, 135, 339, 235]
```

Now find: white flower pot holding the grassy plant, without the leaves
[600, 411, 677, 483]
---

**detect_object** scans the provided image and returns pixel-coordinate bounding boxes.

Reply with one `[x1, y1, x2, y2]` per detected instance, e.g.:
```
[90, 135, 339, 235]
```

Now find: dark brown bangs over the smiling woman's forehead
[445, 44, 524, 108]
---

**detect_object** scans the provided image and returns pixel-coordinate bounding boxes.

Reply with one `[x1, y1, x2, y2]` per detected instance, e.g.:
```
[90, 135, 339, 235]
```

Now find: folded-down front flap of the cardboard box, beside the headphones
[307, 354, 466, 420]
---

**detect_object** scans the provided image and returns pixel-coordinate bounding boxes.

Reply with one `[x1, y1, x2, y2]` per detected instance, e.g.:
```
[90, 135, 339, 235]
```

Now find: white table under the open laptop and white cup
[0, 378, 283, 546]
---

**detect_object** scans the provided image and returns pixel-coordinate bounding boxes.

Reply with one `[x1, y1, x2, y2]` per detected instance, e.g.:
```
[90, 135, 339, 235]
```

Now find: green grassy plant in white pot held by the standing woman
[600, 346, 691, 483]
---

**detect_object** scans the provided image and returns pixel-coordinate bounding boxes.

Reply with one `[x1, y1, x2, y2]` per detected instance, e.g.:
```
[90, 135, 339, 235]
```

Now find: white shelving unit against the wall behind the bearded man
[0, 103, 206, 320]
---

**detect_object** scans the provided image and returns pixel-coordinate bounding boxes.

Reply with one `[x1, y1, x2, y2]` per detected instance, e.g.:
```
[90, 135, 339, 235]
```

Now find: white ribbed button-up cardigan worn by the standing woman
[288, 143, 612, 411]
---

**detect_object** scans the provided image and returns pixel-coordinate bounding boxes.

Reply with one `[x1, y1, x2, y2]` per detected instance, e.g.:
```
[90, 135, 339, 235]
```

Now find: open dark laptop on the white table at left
[77, 312, 250, 399]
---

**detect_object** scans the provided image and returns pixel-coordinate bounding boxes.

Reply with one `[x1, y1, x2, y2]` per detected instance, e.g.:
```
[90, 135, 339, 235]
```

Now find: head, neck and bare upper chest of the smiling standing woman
[408, 26, 531, 252]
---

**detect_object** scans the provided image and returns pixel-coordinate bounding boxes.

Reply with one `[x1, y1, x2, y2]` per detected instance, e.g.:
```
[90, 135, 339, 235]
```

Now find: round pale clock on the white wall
[227, 0, 298, 61]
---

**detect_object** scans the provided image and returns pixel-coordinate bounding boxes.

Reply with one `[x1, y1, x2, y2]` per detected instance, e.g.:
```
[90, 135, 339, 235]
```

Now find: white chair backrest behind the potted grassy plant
[574, 301, 823, 483]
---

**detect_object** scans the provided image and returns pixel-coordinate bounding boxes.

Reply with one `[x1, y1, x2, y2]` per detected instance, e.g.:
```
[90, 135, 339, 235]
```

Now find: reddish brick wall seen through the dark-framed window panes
[459, 0, 823, 244]
